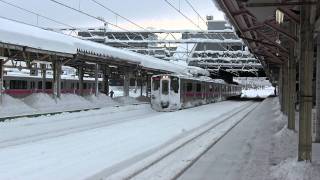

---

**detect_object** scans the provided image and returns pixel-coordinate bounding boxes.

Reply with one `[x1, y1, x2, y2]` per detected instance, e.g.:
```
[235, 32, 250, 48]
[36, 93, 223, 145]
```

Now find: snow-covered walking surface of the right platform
[179, 98, 318, 180]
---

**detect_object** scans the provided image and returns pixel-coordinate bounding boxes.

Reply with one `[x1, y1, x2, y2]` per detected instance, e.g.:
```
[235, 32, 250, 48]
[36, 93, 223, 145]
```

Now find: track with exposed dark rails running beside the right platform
[106, 103, 260, 179]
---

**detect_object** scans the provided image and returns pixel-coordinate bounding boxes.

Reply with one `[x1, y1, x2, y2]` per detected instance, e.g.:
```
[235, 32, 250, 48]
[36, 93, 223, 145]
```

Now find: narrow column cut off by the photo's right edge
[315, 35, 320, 143]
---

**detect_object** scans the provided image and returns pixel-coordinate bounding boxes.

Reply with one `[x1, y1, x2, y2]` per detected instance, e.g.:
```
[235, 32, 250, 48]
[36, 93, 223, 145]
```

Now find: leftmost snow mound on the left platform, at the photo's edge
[0, 94, 37, 117]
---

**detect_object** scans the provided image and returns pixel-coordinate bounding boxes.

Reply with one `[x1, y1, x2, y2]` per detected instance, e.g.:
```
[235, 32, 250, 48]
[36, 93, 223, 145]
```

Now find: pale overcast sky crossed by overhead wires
[0, 0, 224, 30]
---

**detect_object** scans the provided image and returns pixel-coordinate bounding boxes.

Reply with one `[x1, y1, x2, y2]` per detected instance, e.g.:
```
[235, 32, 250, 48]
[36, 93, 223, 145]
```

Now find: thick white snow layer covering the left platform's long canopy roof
[0, 18, 208, 74]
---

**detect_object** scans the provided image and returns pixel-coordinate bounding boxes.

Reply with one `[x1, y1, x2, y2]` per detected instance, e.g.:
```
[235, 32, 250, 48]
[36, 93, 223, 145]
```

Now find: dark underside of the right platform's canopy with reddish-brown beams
[213, 0, 320, 76]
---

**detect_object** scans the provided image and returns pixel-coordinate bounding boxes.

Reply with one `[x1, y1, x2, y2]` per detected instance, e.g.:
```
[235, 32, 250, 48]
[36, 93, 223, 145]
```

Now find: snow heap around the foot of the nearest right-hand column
[271, 158, 320, 180]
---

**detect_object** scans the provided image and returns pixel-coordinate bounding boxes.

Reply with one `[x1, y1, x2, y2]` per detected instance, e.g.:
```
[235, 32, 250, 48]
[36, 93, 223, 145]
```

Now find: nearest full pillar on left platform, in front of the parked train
[52, 59, 62, 99]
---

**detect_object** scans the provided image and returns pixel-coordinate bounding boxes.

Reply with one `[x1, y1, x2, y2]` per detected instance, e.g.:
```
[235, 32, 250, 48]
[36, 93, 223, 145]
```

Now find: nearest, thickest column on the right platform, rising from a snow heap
[298, 6, 314, 161]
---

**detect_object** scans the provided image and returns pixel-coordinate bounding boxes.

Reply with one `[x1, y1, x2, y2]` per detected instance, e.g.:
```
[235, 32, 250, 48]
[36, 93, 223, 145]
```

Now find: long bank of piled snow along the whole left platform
[0, 93, 146, 118]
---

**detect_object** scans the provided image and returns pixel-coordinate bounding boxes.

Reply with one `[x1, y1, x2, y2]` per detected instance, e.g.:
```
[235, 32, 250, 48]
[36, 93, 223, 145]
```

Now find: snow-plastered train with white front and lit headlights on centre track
[151, 74, 242, 111]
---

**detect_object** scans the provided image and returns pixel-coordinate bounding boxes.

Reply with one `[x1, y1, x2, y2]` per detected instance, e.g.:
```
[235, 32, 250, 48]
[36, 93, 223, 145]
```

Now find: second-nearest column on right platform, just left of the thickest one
[288, 23, 297, 130]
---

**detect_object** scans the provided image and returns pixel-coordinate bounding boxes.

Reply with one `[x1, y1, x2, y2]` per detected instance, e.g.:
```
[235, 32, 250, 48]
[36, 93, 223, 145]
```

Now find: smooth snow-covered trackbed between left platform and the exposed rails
[0, 101, 248, 180]
